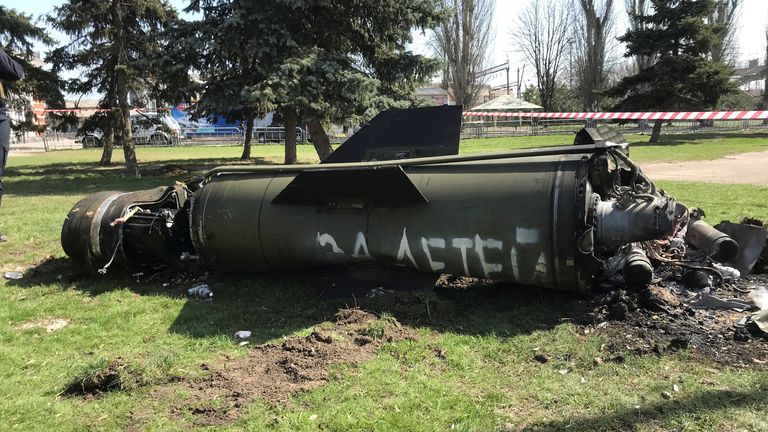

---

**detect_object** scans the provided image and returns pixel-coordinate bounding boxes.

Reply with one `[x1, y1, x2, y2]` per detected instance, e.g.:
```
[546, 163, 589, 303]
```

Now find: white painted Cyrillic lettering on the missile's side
[317, 228, 547, 282]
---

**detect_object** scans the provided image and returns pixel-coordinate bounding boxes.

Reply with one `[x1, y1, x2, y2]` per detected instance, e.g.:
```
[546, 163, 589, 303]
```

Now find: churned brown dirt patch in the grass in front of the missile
[152, 309, 415, 426]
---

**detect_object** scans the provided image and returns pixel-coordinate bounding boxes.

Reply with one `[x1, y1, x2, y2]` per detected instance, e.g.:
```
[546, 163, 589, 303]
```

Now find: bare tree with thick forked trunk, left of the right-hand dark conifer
[571, 0, 615, 111]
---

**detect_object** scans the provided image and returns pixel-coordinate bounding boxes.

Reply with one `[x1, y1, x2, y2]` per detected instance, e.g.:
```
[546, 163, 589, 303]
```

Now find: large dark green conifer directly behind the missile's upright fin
[190, 0, 442, 163]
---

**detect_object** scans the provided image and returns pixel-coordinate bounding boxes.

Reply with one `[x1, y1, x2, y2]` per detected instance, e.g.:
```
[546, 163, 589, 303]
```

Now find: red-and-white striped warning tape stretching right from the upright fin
[464, 111, 768, 120]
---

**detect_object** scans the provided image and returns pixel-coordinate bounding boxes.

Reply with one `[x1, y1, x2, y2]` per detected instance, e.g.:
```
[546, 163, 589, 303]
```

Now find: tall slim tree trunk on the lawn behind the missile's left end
[112, 1, 141, 177]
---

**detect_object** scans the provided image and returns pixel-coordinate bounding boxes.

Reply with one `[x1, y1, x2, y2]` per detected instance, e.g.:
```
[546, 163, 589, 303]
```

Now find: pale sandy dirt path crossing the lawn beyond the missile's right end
[642, 152, 768, 186]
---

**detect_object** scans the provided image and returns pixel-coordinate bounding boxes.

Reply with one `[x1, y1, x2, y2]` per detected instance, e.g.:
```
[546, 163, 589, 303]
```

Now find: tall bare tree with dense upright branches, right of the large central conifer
[432, 0, 496, 107]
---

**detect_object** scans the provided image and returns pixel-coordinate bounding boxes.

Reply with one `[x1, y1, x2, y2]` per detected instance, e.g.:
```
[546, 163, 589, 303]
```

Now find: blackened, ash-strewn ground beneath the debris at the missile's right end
[585, 275, 768, 367]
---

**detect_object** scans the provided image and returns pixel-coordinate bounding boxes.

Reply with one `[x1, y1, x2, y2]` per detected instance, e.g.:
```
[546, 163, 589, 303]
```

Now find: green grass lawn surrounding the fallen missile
[0, 134, 768, 431]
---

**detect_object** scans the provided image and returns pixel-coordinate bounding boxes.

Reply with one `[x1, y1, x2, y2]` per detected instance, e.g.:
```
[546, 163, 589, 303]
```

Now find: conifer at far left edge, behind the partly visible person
[0, 6, 64, 121]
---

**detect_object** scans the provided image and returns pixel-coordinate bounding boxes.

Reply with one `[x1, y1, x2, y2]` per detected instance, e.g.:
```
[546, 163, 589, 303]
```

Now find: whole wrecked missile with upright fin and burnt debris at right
[61, 107, 768, 354]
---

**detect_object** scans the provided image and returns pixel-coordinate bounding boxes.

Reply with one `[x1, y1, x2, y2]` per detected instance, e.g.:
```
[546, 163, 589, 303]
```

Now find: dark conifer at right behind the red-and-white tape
[608, 0, 735, 142]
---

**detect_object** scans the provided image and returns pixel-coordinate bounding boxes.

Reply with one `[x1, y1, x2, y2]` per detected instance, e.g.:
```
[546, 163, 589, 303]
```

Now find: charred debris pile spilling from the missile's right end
[580, 209, 768, 365]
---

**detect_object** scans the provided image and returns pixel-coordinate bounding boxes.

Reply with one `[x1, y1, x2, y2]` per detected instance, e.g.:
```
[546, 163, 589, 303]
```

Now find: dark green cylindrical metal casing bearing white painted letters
[190, 154, 592, 292]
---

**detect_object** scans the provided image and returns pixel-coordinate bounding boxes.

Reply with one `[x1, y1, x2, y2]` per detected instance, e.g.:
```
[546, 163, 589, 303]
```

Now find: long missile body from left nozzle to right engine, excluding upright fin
[62, 146, 675, 292]
